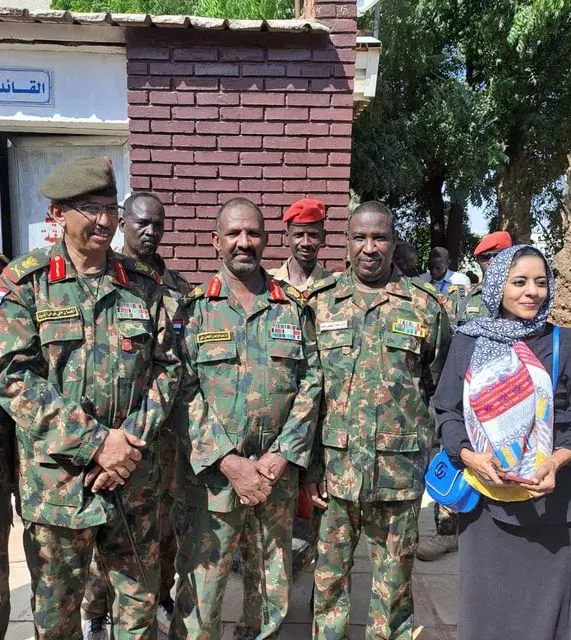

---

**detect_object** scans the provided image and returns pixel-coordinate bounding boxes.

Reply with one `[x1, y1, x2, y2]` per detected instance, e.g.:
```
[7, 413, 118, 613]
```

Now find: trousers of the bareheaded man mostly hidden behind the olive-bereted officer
[82, 428, 176, 620]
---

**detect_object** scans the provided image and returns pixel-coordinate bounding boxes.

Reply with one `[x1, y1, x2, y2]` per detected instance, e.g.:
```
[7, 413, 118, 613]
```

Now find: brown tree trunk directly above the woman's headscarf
[496, 154, 534, 244]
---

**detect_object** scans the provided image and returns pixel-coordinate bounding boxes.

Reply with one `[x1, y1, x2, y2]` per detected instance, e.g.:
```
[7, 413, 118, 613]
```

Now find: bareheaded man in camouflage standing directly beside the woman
[306, 202, 449, 640]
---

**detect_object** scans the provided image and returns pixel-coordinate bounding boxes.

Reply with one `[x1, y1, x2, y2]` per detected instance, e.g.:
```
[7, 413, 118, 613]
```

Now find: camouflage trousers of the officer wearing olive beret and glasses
[24, 505, 158, 640]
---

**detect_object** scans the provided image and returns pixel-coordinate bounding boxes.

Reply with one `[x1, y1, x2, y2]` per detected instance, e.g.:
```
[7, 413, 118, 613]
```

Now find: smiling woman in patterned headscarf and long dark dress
[434, 245, 571, 640]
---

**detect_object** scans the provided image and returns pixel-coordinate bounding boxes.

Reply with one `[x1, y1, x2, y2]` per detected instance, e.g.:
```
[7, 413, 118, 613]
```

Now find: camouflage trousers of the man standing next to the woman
[312, 496, 420, 640]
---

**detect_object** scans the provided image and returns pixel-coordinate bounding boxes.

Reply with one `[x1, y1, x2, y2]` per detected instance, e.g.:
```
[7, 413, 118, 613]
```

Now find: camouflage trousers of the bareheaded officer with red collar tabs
[169, 496, 295, 640]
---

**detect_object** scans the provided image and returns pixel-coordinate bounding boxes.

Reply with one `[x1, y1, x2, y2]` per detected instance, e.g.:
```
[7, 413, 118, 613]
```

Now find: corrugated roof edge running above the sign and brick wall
[0, 7, 329, 33]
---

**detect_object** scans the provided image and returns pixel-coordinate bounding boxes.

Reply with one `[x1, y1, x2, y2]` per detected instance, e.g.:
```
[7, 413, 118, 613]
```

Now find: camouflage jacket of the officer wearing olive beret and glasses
[0, 242, 181, 529]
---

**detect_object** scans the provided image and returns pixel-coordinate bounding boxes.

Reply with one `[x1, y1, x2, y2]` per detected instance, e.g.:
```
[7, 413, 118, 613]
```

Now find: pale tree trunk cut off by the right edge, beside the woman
[551, 155, 571, 327]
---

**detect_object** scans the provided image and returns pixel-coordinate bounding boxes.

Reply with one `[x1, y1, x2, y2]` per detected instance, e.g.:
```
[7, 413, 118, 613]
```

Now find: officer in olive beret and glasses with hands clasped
[0, 158, 180, 640]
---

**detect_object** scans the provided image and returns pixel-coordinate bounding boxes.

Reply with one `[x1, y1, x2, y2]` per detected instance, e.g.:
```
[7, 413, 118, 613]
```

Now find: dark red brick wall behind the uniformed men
[127, 1, 356, 282]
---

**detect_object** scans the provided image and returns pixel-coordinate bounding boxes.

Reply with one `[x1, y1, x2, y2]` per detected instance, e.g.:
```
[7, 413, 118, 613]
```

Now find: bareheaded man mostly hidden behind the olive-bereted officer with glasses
[83, 191, 190, 640]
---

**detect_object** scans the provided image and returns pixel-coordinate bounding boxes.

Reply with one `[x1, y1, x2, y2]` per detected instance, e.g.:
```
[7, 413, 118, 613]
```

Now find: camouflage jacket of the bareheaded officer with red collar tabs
[177, 273, 322, 512]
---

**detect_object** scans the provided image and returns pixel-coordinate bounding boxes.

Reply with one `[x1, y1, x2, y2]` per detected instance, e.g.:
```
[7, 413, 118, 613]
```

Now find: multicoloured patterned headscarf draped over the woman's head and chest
[458, 245, 555, 501]
